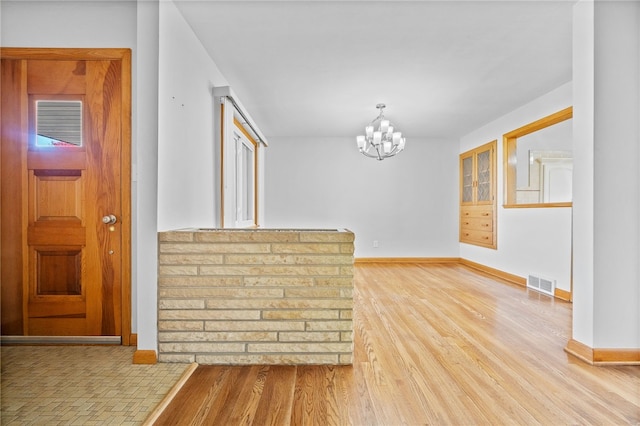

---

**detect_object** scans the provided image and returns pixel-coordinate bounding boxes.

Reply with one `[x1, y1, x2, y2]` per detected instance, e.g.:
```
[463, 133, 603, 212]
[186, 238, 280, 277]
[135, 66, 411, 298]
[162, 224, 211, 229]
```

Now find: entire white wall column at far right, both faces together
[573, 1, 640, 349]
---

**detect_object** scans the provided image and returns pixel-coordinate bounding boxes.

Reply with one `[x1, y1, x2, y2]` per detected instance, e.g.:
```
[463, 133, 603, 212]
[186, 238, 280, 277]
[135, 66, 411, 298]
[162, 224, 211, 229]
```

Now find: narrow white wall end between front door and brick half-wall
[131, 0, 159, 350]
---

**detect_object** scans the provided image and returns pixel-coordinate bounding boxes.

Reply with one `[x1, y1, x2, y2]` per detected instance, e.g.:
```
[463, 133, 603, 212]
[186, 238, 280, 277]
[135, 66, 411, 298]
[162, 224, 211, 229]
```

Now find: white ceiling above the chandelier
[175, 0, 575, 142]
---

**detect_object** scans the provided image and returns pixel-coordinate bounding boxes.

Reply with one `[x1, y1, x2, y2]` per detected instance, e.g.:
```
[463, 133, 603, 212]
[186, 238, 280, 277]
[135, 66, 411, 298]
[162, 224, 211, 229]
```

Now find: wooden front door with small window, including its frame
[0, 49, 130, 344]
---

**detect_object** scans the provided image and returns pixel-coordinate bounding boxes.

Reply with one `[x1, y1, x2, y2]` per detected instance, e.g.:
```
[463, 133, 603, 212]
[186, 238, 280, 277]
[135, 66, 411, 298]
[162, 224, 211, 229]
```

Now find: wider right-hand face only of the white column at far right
[594, 1, 640, 348]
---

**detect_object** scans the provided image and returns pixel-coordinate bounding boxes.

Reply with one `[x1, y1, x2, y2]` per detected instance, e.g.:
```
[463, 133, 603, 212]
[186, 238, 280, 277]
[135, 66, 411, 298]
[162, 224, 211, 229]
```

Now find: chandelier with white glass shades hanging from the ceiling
[356, 104, 405, 160]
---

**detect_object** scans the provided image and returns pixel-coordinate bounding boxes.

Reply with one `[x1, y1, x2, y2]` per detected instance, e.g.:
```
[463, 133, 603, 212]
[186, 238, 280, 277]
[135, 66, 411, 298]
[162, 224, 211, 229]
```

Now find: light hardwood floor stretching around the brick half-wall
[155, 264, 640, 425]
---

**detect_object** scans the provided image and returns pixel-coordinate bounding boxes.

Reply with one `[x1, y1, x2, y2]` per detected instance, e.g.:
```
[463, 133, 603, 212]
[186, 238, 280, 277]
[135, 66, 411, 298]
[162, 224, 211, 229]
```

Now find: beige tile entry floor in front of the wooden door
[0, 346, 189, 426]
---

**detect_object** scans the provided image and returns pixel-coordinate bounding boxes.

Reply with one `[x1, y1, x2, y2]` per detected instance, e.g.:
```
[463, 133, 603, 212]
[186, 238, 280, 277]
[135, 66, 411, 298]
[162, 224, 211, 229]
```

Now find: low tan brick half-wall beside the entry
[158, 229, 354, 364]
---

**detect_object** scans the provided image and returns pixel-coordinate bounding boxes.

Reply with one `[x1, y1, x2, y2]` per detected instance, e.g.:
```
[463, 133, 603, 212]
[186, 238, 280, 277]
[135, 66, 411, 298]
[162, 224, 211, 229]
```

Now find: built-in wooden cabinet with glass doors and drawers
[460, 141, 497, 249]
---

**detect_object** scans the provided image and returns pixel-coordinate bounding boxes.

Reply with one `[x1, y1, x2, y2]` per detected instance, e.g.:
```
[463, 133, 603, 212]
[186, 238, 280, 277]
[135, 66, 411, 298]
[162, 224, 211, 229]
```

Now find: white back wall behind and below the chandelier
[265, 135, 458, 257]
